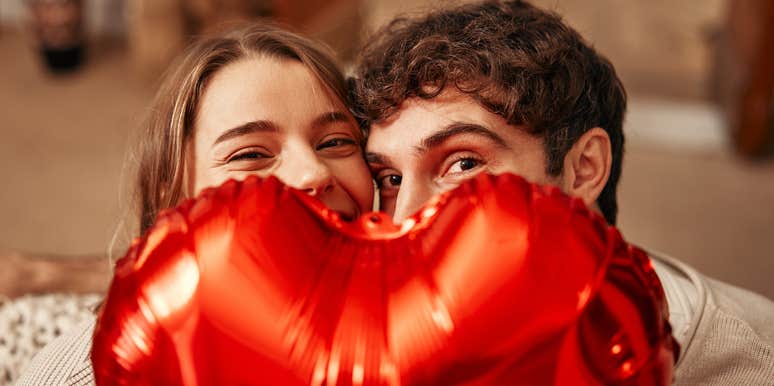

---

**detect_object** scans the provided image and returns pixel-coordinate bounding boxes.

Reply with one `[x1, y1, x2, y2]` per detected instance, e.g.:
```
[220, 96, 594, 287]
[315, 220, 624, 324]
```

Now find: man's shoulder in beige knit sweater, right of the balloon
[651, 255, 774, 385]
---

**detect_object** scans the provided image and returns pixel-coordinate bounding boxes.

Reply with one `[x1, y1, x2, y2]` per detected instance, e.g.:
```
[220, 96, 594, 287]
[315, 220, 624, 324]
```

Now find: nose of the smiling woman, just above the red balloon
[276, 151, 334, 196]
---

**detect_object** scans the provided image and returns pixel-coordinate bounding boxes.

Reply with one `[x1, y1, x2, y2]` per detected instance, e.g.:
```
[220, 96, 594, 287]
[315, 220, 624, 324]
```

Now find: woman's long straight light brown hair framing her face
[135, 23, 349, 233]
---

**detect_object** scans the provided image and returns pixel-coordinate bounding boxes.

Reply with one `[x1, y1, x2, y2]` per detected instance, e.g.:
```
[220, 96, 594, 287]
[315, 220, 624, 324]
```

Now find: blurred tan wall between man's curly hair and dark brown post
[537, 0, 725, 99]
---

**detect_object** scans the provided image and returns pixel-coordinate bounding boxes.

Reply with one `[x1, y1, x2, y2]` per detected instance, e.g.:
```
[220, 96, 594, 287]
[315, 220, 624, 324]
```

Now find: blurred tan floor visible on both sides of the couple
[0, 32, 774, 297]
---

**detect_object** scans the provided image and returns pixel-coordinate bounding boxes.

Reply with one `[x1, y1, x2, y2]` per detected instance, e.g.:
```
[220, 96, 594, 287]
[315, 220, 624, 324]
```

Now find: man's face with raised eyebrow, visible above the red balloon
[366, 89, 560, 222]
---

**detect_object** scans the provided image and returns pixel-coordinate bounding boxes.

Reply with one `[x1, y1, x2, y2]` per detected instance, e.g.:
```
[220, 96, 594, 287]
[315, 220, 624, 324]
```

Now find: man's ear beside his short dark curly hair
[562, 127, 613, 209]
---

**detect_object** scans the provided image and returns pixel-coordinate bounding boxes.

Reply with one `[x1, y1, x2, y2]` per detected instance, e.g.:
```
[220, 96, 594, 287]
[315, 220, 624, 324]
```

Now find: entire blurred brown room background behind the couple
[0, 0, 774, 314]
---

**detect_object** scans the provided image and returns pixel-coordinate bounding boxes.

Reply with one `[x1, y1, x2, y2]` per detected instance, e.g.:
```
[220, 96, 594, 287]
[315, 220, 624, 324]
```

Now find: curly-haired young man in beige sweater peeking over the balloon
[355, 1, 774, 385]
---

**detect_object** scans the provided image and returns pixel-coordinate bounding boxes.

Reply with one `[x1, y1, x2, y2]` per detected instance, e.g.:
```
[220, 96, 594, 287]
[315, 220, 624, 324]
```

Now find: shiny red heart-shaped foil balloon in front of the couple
[91, 175, 677, 386]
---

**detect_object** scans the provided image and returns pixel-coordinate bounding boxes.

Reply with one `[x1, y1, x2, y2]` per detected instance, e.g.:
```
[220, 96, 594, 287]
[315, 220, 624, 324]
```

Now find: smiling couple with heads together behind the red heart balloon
[19, 1, 774, 385]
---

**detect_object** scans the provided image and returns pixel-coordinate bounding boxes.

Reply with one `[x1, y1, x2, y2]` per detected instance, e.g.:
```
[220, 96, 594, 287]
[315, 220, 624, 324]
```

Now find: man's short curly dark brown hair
[352, 1, 626, 224]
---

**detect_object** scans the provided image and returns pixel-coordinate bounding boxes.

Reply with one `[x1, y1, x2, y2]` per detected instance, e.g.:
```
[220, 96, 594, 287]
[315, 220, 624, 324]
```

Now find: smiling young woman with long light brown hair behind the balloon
[18, 24, 373, 385]
